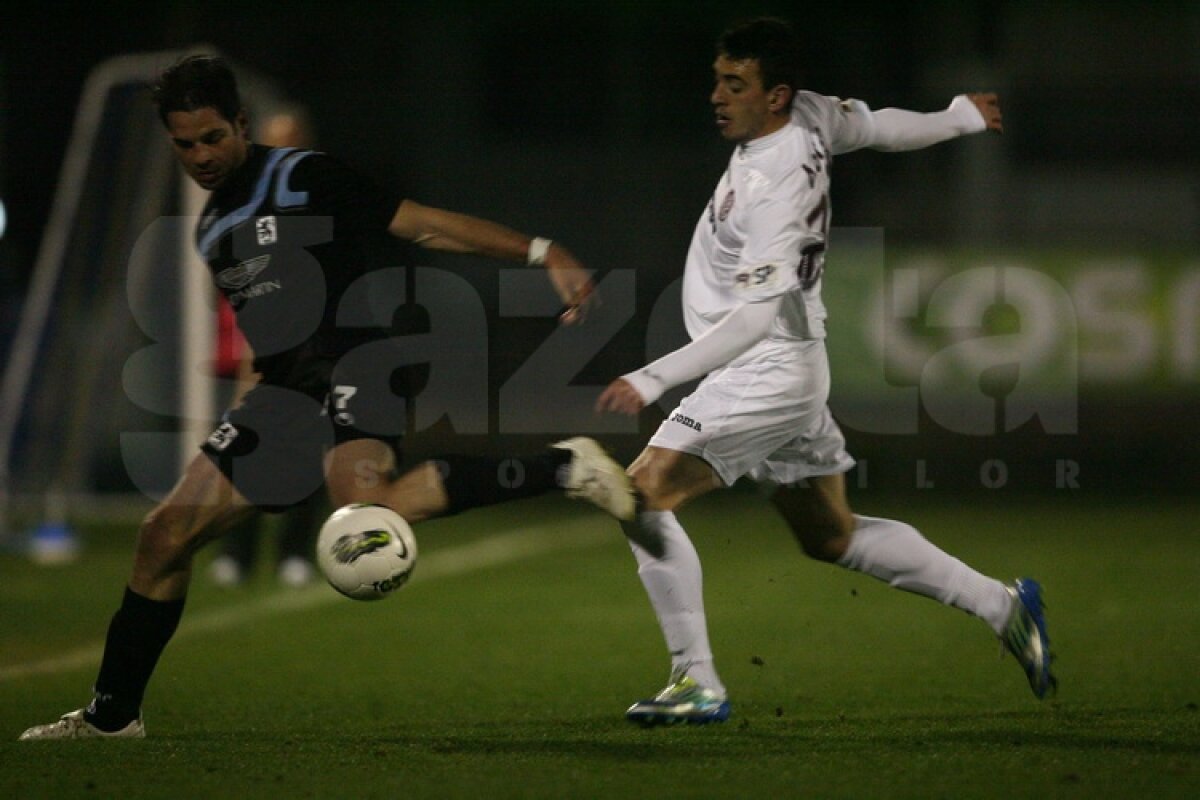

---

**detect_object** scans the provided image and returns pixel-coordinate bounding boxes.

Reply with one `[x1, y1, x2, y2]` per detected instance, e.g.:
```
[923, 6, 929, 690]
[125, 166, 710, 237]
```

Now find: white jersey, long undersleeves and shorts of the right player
[638, 92, 986, 483]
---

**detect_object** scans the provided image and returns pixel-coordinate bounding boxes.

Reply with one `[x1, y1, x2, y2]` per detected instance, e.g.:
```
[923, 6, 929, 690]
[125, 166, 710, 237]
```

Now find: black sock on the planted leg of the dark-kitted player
[84, 588, 184, 730]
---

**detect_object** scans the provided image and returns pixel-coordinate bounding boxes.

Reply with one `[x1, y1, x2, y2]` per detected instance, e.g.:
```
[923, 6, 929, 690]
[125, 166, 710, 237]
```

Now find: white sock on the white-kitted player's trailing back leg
[838, 515, 1013, 636]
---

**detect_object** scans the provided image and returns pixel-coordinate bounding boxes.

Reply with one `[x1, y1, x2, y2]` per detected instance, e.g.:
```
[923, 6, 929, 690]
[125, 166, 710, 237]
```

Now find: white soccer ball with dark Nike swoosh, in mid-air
[317, 503, 416, 600]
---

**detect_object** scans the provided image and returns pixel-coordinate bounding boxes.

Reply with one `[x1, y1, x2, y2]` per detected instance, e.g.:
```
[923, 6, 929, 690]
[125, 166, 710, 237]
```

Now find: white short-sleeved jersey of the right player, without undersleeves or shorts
[683, 91, 872, 361]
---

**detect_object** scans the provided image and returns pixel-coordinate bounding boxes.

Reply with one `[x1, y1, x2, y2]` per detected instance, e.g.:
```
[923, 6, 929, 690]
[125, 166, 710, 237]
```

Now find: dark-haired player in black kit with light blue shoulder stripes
[20, 56, 632, 739]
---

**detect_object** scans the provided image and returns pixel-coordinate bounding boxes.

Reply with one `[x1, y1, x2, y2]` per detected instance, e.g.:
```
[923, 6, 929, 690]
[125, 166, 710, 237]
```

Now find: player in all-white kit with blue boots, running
[596, 18, 1056, 724]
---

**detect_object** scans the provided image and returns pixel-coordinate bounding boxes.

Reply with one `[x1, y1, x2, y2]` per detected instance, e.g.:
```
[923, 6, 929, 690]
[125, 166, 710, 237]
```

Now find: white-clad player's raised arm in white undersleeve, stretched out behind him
[866, 92, 1004, 152]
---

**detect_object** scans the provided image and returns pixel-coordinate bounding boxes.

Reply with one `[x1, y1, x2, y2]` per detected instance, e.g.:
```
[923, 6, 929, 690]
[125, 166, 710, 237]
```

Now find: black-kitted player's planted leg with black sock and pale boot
[20, 456, 250, 740]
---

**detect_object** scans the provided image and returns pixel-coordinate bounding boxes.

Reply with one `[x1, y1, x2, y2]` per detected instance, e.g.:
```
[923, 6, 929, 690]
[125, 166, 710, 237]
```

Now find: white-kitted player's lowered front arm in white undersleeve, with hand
[596, 295, 784, 414]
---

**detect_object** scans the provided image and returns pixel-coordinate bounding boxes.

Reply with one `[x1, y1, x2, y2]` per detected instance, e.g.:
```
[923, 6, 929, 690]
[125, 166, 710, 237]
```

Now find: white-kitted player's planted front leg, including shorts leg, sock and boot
[623, 350, 827, 724]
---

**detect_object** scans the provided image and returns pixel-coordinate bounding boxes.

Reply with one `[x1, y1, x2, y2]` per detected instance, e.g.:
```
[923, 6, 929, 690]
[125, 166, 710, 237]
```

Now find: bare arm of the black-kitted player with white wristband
[388, 200, 595, 323]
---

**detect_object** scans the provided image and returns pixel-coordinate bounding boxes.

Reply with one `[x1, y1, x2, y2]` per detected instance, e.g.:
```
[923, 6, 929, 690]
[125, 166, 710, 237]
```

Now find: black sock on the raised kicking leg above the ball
[436, 447, 571, 515]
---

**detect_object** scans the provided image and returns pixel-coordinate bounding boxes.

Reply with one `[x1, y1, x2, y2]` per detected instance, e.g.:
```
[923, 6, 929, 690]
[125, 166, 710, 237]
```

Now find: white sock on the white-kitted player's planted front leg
[620, 511, 725, 697]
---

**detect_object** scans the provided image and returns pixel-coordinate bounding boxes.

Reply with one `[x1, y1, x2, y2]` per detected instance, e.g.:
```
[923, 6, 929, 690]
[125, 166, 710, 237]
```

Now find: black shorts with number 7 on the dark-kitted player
[200, 350, 406, 512]
